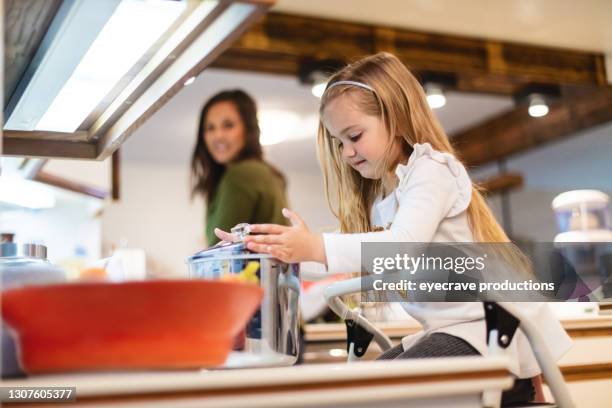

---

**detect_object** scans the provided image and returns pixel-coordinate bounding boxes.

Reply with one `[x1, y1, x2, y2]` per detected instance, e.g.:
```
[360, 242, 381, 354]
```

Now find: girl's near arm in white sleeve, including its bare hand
[245, 157, 462, 273]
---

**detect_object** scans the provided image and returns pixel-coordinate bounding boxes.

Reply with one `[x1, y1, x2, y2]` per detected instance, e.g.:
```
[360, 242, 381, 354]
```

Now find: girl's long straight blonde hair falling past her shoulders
[317, 52, 510, 242]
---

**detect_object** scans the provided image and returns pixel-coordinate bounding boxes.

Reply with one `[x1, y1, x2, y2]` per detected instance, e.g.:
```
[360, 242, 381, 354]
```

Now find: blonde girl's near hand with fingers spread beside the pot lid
[244, 208, 327, 264]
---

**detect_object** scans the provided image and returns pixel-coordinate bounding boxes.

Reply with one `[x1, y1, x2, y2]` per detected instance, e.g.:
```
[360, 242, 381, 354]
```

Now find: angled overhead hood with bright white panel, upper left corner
[3, 0, 274, 160]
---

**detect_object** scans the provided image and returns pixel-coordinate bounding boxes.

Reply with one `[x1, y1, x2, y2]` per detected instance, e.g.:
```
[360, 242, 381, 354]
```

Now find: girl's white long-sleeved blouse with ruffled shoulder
[323, 143, 571, 378]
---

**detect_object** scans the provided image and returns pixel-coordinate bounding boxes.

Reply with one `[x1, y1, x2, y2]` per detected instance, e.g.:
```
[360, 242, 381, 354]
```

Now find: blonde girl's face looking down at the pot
[322, 93, 399, 179]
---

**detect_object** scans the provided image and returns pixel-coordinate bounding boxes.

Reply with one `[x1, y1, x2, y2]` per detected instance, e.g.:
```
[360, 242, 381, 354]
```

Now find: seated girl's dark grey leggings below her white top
[378, 333, 535, 407]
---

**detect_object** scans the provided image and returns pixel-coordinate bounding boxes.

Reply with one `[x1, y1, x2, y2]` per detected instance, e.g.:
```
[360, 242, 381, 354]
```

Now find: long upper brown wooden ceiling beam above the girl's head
[213, 13, 606, 95]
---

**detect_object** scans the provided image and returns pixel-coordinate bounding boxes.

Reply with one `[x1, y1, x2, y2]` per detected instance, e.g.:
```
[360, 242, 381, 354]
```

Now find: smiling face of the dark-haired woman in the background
[203, 101, 246, 164]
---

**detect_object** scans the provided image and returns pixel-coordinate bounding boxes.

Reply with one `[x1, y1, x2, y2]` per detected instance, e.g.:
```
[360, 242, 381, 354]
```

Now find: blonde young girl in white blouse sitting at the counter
[217, 53, 570, 403]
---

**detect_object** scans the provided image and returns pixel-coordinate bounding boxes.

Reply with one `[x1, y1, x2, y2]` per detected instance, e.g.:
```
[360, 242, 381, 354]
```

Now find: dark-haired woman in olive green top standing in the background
[191, 90, 287, 246]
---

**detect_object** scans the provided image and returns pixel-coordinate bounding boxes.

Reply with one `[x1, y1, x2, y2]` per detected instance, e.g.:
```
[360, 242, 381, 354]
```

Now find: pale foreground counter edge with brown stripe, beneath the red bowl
[0, 357, 512, 408]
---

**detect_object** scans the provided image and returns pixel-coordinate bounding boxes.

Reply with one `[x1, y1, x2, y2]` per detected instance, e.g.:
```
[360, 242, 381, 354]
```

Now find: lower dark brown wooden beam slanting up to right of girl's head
[451, 86, 612, 167]
